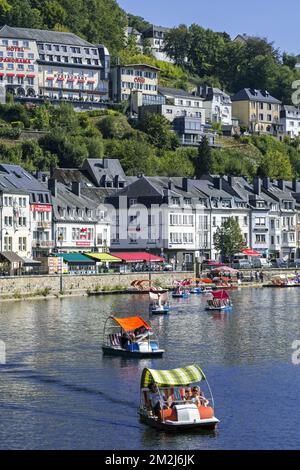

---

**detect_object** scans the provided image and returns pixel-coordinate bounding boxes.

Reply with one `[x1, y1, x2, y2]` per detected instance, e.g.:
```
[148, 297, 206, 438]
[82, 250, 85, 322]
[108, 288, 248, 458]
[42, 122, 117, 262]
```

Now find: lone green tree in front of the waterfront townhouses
[213, 217, 245, 262]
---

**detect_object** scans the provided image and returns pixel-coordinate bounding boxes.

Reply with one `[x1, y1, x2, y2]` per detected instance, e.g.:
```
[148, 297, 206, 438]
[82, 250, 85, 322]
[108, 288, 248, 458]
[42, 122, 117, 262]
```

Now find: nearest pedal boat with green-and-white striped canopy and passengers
[139, 364, 219, 431]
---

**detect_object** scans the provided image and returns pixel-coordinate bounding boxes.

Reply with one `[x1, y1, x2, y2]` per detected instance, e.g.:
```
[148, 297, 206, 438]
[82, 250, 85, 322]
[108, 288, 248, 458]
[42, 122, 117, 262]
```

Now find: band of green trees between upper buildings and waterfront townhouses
[0, 102, 300, 179]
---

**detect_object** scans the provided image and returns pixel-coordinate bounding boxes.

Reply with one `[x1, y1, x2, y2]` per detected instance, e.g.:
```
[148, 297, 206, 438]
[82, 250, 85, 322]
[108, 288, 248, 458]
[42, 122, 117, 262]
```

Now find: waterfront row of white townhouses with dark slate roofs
[0, 159, 300, 274]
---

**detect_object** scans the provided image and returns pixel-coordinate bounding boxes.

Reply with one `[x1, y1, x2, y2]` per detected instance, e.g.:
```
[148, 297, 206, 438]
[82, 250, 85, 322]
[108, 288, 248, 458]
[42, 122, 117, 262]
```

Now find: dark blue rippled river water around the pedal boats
[0, 289, 300, 450]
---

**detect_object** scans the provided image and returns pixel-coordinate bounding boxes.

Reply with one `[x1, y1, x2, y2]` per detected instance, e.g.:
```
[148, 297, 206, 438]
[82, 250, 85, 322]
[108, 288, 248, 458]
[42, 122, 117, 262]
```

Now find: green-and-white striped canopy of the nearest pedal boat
[141, 364, 205, 388]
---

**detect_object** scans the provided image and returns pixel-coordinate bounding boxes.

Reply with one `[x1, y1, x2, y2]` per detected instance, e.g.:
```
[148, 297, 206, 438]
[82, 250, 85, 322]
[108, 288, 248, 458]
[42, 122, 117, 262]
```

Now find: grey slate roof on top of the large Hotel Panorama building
[0, 25, 95, 47]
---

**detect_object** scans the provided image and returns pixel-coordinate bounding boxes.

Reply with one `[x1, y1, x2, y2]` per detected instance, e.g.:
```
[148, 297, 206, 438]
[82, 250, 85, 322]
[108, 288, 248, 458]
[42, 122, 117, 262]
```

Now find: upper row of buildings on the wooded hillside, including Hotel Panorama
[0, 26, 300, 140]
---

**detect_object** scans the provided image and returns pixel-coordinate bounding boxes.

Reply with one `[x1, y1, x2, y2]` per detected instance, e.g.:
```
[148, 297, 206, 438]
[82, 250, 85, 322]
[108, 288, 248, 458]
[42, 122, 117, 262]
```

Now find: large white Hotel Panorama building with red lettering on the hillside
[0, 26, 110, 101]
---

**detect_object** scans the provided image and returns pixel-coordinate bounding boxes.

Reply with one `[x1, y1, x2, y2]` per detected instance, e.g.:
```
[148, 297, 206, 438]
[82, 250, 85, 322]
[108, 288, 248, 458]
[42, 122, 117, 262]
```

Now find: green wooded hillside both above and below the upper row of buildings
[0, 0, 300, 178]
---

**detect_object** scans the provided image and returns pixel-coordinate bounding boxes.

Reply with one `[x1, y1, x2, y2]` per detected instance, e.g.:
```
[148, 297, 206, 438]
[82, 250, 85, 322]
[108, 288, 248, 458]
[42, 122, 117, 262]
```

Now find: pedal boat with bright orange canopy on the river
[102, 316, 164, 358]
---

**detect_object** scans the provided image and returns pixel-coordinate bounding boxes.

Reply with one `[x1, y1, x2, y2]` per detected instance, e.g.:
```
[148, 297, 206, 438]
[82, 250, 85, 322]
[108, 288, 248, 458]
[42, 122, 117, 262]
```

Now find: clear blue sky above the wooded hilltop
[117, 0, 300, 54]
